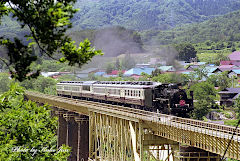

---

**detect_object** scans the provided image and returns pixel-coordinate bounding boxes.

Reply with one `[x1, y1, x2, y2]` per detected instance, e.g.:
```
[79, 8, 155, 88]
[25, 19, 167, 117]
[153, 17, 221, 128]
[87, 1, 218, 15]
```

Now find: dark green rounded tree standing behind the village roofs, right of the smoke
[175, 43, 197, 61]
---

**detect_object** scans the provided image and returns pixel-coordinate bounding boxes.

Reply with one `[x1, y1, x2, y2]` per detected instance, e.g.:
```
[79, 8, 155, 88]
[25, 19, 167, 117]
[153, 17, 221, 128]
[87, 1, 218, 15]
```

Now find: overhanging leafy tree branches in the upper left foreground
[0, 0, 101, 81]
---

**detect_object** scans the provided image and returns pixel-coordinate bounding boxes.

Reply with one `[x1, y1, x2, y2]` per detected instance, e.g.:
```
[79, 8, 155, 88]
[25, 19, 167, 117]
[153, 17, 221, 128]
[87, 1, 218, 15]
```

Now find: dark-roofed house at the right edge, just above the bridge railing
[218, 88, 240, 106]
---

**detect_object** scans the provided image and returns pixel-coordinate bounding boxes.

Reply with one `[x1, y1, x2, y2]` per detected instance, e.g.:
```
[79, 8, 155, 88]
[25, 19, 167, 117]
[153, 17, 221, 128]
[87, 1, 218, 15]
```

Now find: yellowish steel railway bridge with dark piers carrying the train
[25, 91, 240, 161]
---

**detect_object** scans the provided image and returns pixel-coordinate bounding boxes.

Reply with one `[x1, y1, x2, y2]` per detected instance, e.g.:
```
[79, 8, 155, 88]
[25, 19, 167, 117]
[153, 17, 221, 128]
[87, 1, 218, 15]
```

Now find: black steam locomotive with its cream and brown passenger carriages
[56, 81, 193, 117]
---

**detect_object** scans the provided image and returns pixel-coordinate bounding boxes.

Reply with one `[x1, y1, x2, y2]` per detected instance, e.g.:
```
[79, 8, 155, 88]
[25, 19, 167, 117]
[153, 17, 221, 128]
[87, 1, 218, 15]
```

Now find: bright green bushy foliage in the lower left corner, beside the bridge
[0, 84, 70, 161]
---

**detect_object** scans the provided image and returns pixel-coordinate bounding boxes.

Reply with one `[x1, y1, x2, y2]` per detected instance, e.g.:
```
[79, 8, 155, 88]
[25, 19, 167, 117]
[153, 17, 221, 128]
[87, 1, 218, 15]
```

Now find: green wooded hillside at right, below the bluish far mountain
[141, 11, 240, 45]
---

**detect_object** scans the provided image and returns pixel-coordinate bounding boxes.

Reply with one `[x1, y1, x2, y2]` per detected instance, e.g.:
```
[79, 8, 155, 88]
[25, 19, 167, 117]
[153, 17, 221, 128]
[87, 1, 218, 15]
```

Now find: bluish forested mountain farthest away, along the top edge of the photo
[73, 0, 240, 30]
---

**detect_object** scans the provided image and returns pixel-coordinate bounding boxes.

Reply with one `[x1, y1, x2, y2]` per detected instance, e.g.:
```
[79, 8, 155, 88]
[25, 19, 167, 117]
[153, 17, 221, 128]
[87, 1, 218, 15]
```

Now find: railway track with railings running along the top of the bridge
[26, 91, 240, 142]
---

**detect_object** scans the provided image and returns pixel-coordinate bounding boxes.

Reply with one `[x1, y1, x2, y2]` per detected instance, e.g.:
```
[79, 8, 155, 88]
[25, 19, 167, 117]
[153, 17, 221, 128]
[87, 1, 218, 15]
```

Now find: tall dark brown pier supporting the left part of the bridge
[56, 109, 89, 161]
